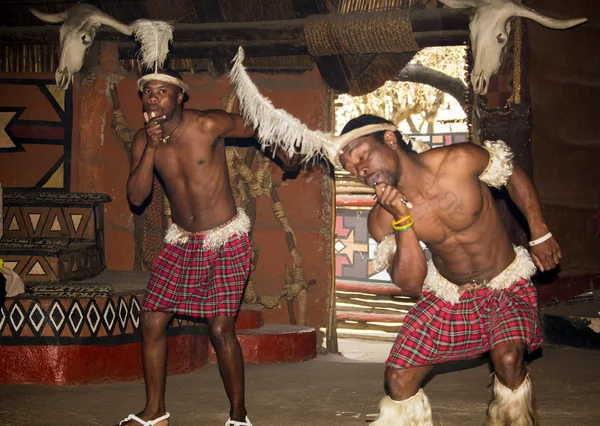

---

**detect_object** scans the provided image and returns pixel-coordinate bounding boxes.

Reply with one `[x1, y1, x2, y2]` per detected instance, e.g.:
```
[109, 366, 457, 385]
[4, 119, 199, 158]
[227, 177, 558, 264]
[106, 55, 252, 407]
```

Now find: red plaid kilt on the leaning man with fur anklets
[386, 279, 543, 369]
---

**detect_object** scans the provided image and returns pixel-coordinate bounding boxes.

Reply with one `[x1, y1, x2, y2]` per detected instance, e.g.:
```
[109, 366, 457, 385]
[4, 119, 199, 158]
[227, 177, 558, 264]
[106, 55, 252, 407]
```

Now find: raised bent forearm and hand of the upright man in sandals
[127, 113, 164, 206]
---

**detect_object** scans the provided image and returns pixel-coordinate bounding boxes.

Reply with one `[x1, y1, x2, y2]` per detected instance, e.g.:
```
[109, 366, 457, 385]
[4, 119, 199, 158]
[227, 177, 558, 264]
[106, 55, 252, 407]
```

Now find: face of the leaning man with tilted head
[340, 132, 398, 187]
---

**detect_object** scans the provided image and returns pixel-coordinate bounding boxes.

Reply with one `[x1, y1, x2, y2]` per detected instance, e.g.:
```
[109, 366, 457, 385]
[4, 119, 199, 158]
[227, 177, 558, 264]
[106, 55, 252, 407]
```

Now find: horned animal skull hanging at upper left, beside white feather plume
[29, 4, 132, 90]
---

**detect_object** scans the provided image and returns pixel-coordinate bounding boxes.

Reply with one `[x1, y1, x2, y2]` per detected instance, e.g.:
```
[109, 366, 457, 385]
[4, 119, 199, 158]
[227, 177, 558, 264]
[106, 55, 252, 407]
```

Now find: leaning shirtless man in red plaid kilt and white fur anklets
[338, 115, 561, 426]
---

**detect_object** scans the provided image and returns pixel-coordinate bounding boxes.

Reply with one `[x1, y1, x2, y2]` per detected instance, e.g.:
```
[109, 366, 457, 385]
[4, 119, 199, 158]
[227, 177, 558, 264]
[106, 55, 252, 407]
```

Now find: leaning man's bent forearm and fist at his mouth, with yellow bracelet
[368, 190, 427, 296]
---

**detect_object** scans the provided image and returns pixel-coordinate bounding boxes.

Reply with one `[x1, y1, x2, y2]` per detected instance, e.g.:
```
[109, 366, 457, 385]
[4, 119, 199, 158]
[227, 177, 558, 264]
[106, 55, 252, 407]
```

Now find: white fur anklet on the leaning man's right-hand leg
[485, 374, 539, 426]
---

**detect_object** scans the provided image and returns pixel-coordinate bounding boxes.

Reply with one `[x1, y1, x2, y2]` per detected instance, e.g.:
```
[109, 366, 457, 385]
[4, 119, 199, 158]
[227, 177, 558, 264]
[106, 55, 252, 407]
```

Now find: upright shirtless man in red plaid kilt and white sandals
[119, 70, 254, 426]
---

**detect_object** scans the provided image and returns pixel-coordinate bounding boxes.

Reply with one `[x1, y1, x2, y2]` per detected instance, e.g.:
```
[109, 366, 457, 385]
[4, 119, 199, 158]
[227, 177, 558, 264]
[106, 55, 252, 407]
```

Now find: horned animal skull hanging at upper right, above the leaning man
[439, 0, 587, 95]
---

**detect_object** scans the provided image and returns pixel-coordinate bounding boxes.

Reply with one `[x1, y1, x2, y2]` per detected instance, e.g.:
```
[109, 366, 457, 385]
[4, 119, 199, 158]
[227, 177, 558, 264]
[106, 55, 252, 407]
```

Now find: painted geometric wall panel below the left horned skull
[0, 78, 72, 191]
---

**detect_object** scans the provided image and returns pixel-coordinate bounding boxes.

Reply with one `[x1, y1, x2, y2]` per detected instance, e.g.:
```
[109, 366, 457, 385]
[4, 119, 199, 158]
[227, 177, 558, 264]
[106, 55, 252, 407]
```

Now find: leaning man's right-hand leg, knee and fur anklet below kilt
[486, 343, 538, 426]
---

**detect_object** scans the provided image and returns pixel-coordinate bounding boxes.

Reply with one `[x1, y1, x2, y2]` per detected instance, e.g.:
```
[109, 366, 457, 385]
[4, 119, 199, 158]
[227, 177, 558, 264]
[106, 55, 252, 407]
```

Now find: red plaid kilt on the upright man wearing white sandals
[142, 231, 252, 318]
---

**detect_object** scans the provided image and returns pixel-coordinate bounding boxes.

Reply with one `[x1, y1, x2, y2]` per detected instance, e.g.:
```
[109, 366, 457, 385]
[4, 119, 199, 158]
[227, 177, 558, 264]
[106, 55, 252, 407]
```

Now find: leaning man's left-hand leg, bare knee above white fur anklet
[373, 366, 433, 426]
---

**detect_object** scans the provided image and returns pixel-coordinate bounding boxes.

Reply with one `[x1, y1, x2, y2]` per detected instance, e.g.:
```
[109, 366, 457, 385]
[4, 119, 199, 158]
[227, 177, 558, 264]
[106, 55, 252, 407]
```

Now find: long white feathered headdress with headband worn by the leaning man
[229, 47, 414, 168]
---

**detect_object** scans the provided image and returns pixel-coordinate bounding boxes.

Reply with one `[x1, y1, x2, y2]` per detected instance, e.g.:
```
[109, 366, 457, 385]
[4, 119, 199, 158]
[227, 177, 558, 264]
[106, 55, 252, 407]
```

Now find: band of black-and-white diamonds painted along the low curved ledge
[0, 295, 205, 345]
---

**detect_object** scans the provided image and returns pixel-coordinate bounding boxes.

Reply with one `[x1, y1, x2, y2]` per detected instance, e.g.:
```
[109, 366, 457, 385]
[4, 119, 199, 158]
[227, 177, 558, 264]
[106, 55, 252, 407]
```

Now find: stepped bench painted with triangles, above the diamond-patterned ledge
[0, 188, 111, 284]
